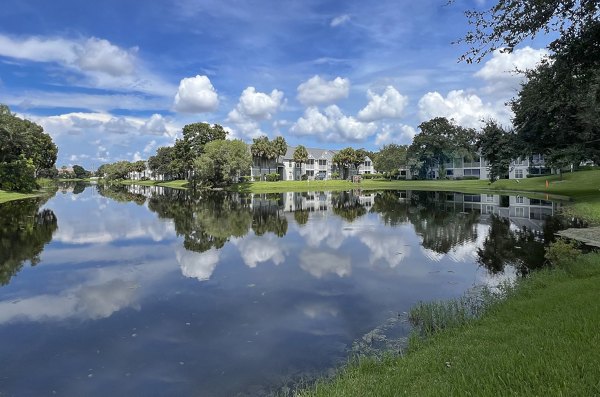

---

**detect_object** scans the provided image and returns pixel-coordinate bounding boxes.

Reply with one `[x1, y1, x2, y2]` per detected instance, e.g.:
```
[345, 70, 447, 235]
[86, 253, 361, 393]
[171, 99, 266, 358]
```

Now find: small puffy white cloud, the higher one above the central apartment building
[298, 76, 350, 106]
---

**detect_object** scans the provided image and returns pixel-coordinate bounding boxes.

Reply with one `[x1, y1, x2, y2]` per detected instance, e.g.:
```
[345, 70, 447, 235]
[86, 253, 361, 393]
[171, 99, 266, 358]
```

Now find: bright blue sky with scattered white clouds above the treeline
[0, 0, 548, 169]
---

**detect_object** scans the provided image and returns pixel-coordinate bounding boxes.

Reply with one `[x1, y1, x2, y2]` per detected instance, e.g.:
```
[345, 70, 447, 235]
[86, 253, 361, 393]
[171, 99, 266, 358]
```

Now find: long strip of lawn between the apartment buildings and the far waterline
[230, 170, 600, 224]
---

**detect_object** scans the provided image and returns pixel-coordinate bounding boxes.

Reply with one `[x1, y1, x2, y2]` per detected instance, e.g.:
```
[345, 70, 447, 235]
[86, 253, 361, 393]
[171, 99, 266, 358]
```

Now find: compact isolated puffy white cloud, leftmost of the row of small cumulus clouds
[173, 75, 219, 113]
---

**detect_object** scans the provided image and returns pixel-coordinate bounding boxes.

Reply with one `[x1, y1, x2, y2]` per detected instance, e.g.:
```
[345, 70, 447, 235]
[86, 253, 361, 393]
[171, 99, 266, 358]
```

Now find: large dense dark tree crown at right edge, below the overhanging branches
[512, 22, 600, 162]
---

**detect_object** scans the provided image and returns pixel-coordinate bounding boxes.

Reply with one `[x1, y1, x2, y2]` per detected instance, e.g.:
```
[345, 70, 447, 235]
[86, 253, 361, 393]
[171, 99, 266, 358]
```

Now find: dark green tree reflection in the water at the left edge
[0, 199, 58, 285]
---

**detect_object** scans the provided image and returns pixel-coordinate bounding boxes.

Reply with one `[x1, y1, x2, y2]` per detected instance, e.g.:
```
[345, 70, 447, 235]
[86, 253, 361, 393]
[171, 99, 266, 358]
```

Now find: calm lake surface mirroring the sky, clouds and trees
[0, 185, 580, 396]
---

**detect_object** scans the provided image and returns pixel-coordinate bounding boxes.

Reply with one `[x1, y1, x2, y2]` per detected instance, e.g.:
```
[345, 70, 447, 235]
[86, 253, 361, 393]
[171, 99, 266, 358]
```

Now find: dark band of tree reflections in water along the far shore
[98, 187, 581, 274]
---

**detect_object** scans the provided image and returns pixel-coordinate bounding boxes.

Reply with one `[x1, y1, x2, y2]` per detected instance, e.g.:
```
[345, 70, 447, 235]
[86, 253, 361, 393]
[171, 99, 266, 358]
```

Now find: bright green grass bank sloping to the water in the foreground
[299, 254, 600, 396]
